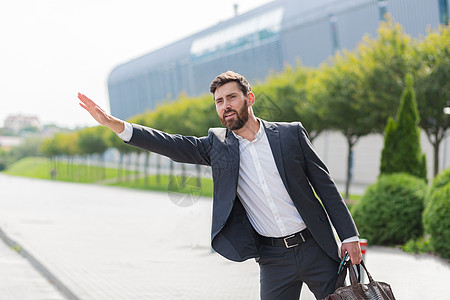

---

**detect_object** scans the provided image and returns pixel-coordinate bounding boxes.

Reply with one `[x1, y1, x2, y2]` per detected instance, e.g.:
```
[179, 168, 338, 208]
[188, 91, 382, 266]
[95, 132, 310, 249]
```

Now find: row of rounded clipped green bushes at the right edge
[352, 169, 450, 258]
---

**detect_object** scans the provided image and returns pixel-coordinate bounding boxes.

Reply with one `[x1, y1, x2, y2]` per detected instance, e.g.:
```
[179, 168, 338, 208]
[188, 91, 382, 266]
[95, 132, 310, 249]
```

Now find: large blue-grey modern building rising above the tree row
[108, 0, 450, 119]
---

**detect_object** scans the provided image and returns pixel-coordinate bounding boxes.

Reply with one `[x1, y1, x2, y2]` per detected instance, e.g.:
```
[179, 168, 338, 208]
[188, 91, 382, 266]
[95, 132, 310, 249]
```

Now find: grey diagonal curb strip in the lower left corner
[0, 228, 81, 300]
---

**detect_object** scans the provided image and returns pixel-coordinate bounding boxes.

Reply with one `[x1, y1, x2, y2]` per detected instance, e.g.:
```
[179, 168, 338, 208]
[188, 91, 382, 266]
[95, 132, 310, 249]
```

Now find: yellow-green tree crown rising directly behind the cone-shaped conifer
[356, 16, 416, 133]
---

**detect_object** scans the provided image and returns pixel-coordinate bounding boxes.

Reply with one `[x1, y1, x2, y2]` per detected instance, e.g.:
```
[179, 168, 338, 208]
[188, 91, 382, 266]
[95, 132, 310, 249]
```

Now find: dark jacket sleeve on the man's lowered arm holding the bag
[298, 123, 358, 241]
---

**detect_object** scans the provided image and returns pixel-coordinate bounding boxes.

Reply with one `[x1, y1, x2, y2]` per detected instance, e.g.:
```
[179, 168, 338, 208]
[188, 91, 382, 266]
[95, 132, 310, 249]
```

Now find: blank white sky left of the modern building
[0, 0, 270, 128]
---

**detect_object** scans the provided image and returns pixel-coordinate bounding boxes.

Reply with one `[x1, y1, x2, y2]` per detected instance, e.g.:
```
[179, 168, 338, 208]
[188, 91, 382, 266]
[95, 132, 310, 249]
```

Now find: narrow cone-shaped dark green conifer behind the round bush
[380, 74, 427, 180]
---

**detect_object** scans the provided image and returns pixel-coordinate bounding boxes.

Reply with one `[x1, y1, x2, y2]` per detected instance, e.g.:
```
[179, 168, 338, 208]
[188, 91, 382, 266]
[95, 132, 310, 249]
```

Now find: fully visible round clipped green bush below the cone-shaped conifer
[352, 173, 427, 245]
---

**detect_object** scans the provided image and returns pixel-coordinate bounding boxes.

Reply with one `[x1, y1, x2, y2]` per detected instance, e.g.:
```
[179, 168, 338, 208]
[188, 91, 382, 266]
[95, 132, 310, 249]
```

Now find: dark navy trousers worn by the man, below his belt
[258, 237, 339, 300]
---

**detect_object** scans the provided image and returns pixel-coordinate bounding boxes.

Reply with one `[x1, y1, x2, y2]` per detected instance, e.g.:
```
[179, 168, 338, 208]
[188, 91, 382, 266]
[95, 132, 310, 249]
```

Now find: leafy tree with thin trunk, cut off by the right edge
[415, 26, 450, 176]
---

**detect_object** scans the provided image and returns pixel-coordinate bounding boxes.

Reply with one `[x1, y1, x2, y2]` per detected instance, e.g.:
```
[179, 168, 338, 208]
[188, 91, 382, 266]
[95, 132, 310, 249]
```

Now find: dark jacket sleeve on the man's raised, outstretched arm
[127, 124, 212, 166]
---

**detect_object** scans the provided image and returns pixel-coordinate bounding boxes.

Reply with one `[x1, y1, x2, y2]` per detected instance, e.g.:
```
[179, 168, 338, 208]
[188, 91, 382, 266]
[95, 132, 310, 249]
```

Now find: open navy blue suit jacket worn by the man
[128, 121, 358, 261]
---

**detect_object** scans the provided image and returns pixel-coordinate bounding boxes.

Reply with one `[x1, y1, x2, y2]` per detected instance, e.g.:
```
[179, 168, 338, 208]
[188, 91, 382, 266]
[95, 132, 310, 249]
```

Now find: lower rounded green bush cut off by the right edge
[423, 181, 450, 259]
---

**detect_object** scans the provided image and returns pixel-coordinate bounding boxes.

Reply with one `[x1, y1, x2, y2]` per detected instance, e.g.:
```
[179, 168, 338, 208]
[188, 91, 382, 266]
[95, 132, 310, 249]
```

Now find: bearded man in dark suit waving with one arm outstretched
[78, 71, 361, 300]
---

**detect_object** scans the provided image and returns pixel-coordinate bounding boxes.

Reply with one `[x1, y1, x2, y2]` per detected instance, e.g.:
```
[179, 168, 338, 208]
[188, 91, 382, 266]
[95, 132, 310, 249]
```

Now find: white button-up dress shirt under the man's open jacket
[233, 121, 306, 237]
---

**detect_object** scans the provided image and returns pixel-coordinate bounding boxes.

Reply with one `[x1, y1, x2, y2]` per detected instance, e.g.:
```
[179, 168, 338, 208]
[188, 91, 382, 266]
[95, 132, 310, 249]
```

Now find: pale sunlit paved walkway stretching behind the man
[0, 174, 450, 300]
